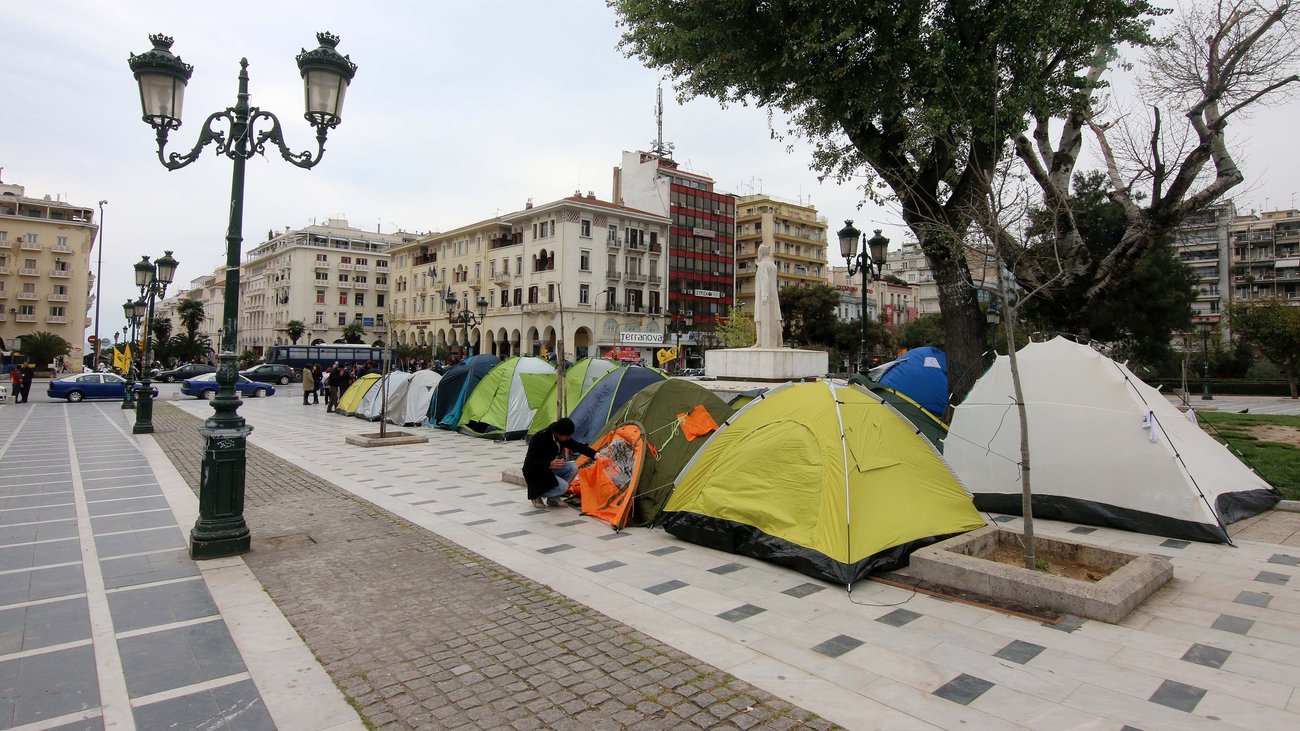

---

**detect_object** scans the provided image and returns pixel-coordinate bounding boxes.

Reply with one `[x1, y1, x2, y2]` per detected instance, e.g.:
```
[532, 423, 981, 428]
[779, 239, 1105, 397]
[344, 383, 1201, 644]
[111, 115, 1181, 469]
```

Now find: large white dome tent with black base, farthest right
[944, 337, 1282, 542]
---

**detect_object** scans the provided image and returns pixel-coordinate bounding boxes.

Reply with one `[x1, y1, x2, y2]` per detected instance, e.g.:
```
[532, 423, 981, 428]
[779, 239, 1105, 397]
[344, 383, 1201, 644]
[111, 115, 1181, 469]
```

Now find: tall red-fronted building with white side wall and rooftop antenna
[612, 152, 736, 331]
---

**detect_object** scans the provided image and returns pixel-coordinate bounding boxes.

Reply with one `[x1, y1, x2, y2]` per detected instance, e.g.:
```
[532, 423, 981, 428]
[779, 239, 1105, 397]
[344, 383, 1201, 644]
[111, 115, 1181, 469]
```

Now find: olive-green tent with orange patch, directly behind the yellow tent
[601, 379, 732, 525]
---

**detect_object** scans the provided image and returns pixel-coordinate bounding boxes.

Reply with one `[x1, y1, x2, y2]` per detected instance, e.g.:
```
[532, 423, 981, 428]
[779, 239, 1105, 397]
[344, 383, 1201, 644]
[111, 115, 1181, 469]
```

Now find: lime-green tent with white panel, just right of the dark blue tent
[456, 355, 555, 440]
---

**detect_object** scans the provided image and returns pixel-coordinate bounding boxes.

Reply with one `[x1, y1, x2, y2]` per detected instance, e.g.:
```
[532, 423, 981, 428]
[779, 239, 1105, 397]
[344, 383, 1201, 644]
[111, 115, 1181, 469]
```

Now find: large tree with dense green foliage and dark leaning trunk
[608, 0, 1160, 398]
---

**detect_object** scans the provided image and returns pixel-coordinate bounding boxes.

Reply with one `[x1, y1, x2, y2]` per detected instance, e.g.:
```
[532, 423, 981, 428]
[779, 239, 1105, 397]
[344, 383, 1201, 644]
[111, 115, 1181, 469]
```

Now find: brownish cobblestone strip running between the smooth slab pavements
[153, 402, 836, 731]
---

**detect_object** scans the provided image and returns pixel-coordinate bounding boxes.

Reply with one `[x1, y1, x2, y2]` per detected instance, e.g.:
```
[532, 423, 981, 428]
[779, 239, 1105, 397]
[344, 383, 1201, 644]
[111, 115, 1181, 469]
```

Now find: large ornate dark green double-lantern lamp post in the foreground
[127, 33, 356, 558]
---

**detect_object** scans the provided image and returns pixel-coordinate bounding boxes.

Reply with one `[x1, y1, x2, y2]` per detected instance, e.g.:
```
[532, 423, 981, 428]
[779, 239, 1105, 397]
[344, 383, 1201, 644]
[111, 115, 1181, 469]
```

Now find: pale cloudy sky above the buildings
[0, 0, 1300, 333]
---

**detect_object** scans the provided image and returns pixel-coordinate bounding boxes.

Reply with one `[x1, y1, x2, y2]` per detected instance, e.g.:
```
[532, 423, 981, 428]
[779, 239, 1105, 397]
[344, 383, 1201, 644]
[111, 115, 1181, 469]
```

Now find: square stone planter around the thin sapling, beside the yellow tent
[907, 525, 1174, 623]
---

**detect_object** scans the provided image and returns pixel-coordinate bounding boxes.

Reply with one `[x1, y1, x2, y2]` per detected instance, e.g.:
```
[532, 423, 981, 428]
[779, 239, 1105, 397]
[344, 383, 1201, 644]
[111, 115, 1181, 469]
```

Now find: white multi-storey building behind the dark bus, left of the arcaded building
[237, 219, 415, 352]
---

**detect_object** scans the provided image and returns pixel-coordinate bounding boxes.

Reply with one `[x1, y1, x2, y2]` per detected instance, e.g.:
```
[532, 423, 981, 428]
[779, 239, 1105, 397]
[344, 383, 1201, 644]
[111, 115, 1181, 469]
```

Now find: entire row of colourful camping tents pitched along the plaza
[330, 338, 1281, 585]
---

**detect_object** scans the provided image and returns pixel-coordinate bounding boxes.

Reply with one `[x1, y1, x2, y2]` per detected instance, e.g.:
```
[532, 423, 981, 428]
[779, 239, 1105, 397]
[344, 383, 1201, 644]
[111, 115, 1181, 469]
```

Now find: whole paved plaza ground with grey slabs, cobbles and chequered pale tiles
[0, 388, 1300, 731]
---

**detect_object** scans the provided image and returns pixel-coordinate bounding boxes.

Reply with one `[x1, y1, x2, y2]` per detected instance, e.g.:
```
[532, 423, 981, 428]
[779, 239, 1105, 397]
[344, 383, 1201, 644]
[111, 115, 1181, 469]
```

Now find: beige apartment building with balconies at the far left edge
[0, 183, 98, 367]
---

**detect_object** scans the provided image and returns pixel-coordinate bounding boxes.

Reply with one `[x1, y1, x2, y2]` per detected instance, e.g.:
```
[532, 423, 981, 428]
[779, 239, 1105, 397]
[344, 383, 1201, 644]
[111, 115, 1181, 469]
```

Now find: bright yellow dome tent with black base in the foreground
[660, 381, 984, 589]
